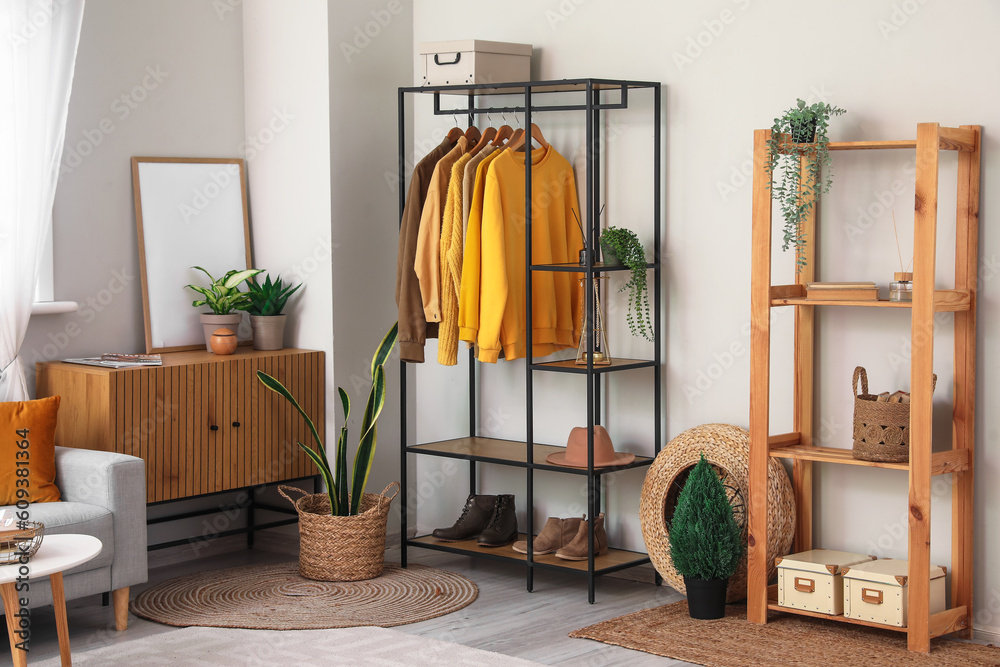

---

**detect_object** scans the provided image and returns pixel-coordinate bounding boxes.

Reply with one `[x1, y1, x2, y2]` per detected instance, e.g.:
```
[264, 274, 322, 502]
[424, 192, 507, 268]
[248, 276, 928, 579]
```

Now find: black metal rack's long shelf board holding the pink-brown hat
[406, 437, 653, 475]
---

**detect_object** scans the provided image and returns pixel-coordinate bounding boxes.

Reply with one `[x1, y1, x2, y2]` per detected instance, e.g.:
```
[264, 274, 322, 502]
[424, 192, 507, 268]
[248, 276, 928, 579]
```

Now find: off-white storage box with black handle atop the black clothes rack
[417, 39, 531, 86]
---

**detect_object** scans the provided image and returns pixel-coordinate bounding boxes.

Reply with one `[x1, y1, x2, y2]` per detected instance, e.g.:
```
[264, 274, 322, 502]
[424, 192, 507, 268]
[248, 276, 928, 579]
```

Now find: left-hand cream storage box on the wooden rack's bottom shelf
[775, 549, 874, 616]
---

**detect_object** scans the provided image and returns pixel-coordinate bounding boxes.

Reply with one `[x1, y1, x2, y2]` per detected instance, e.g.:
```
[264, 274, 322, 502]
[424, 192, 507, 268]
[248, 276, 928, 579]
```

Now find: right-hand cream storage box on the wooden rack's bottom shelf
[844, 558, 947, 628]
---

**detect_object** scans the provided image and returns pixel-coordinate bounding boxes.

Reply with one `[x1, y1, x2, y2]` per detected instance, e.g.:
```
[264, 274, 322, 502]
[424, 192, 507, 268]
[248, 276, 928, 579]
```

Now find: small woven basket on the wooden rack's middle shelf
[852, 366, 937, 463]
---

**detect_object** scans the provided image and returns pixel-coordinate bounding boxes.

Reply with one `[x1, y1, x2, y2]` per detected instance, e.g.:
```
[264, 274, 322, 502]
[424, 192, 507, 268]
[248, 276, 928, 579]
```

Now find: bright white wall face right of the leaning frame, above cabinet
[242, 0, 336, 494]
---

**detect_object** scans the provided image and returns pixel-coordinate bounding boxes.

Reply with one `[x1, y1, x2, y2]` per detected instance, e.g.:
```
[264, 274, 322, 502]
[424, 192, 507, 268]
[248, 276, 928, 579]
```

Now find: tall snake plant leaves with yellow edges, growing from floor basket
[257, 322, 399, 516]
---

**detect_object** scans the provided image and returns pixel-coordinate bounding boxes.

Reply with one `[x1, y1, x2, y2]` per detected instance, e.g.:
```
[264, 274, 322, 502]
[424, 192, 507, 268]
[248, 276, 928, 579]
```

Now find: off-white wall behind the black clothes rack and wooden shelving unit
[410, 0, 1000, 631]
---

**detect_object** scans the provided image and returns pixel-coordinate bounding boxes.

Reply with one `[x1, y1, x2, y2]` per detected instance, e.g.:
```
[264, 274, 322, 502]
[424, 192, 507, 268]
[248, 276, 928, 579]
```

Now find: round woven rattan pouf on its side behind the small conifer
[639, 424, 795, 602]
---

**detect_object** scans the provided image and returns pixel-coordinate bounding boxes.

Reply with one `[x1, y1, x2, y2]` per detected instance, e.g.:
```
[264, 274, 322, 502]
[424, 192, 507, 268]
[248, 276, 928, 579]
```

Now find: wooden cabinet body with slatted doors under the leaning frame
[37, 347, 325, 503]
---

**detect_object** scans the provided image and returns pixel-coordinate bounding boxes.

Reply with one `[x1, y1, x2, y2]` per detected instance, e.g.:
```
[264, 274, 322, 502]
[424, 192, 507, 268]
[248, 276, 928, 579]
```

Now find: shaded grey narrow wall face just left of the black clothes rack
[329, 0, 412, 533]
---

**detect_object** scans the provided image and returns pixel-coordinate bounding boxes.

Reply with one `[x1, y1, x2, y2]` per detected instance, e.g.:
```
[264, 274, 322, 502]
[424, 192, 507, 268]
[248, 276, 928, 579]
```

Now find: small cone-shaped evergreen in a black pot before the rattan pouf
[668, 454, 743, 619]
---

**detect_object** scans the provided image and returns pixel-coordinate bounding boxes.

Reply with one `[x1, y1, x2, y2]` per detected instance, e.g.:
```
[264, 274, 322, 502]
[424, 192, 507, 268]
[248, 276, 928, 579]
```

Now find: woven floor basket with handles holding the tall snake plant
[278, 482, 399, 581]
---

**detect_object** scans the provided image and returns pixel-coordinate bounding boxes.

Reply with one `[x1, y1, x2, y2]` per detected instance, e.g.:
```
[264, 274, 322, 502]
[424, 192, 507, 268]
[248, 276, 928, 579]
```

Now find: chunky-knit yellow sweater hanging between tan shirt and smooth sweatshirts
[438, 153, 472, 366]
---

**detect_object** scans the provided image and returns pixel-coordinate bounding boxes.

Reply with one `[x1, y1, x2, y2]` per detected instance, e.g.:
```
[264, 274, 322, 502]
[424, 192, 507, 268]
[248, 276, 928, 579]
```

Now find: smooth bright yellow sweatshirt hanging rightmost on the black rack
[479, 146, 583, 363]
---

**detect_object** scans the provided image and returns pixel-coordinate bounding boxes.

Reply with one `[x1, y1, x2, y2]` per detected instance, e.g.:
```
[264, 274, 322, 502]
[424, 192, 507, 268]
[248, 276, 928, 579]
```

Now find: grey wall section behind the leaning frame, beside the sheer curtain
[21, 0, 243, 391]
